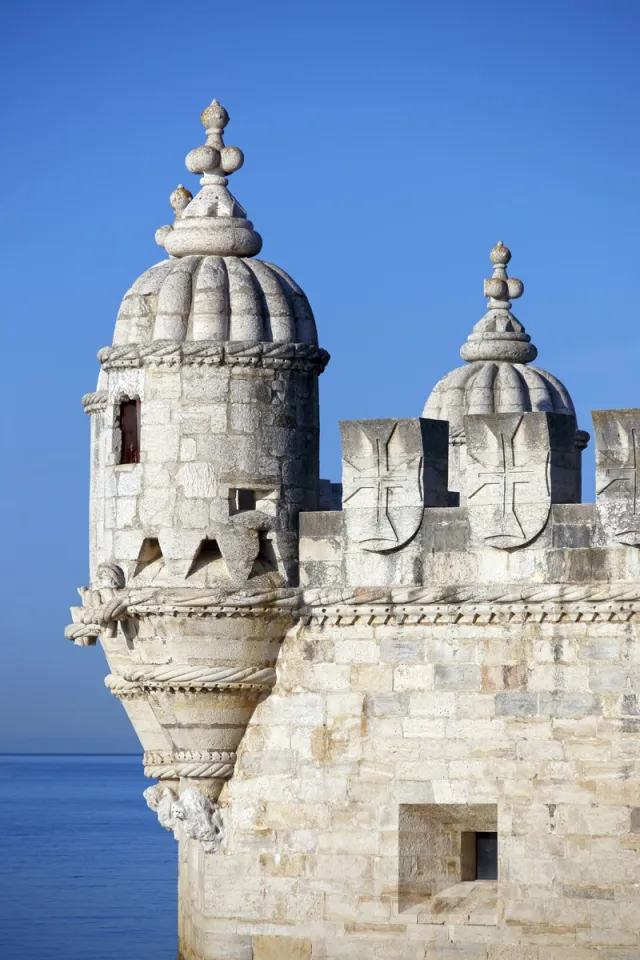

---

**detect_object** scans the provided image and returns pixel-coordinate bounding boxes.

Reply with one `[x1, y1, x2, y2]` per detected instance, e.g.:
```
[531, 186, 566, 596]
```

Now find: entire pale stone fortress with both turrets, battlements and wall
[67, 101, 640, 960]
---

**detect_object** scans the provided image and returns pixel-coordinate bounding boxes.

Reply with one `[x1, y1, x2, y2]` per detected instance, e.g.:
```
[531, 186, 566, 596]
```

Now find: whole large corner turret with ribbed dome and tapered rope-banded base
[68, 100, 328, 797]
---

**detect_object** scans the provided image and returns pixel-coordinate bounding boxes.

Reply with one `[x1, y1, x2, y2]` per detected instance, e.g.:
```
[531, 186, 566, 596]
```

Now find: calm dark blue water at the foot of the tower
[0, 756, 177, 960]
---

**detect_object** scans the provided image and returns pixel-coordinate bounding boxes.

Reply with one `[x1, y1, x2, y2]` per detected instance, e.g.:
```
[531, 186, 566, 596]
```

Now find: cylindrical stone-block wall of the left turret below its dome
[91, 364, 319, 586]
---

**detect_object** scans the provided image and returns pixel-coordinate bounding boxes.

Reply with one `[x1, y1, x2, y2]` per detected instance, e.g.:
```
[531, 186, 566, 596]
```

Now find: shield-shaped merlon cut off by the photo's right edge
[592, 409, 640, 546]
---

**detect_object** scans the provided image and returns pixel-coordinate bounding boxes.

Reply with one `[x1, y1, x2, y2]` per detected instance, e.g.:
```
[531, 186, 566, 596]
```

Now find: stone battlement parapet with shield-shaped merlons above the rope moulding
[300, 410, 640, 588]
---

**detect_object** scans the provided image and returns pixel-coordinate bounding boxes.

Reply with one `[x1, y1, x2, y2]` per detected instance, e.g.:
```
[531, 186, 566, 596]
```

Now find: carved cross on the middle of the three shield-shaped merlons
[468, 431, 549, 540]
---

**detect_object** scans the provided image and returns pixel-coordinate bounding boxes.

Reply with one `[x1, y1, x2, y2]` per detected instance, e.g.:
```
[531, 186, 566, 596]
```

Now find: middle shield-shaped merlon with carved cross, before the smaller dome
[464, 413, 576, 550]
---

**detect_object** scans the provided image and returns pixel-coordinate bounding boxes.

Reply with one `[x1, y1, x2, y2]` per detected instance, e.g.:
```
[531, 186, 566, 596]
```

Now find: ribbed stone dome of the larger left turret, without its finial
[113, 255, 318, 345]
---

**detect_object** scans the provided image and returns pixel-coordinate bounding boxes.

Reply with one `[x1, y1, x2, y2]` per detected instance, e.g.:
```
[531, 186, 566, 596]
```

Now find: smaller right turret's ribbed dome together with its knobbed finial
[423, 241, 575, 437]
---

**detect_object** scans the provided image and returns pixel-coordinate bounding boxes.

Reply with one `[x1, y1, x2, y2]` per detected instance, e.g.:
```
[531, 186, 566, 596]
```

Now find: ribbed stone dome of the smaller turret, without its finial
[423, 360, 575, 436]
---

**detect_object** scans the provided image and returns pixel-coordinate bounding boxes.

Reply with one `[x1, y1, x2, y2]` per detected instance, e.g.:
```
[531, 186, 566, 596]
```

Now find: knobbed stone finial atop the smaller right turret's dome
[460, 240, 538, 363]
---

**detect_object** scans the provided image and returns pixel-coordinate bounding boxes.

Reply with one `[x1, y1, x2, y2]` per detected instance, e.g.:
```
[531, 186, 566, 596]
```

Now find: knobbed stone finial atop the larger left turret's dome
[156, 100, 262, 257]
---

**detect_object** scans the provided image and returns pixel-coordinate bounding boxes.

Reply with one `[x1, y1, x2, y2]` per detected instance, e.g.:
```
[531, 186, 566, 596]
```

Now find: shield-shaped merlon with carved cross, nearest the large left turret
[340, 419, 448, 552]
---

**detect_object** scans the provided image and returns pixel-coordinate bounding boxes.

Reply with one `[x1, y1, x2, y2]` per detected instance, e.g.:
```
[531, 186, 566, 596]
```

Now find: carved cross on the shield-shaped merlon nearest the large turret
[344, 433, 423, 547]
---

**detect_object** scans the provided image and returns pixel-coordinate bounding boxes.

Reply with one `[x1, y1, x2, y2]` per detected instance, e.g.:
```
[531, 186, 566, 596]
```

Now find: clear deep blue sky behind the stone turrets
[0, 0, 640, 750]
